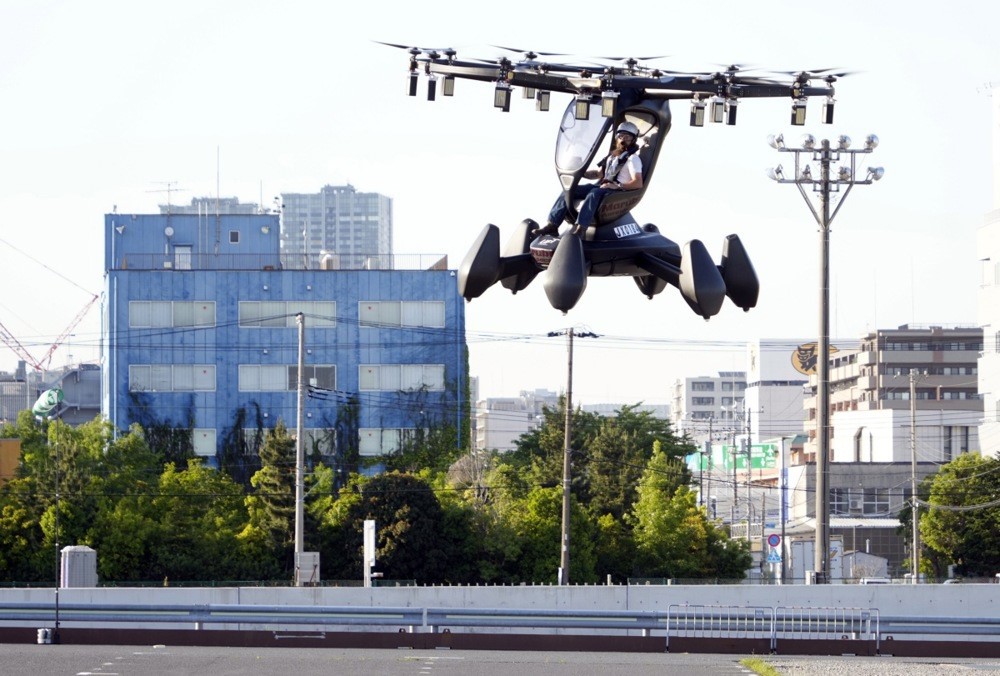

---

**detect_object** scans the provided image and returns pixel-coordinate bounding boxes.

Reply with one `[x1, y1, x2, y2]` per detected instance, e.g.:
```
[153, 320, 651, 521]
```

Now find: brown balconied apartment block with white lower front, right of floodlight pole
[805, 325, 983, 462]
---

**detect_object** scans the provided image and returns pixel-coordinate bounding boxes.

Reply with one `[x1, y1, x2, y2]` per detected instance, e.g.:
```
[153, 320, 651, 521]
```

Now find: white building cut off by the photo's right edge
[977, 86, 1000, 456]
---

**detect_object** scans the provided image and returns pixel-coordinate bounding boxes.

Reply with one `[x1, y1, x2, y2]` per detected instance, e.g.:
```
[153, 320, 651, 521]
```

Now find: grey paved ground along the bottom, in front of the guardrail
[0, 644, 1000, 676]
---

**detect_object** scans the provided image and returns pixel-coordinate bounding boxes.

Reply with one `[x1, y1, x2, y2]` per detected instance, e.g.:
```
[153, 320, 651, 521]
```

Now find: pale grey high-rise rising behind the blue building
[281, 185, 393, 269]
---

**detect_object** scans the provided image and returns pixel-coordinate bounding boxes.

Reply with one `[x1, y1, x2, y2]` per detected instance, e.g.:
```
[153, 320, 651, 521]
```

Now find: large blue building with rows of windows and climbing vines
[102, 214, 468, 463]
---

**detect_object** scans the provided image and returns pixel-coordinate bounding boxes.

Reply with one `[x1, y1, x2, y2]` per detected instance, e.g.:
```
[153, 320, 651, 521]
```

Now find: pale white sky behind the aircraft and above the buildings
[0, 0, 1000, 403]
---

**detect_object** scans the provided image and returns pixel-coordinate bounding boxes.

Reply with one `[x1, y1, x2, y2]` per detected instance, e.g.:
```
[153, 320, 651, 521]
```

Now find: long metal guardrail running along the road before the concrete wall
[0, 602, 1000, 652]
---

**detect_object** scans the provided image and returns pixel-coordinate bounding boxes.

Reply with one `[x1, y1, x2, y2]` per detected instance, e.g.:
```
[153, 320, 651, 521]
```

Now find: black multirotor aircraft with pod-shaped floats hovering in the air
[385, 43, 846, 319]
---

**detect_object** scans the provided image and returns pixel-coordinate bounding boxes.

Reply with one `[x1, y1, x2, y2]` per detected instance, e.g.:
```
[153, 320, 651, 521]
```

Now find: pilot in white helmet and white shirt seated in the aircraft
[535, 122, 642, 235]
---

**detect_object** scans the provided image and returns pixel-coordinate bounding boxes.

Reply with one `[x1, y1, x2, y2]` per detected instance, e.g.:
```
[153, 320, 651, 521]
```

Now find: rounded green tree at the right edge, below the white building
[920, 453, 1000, 577]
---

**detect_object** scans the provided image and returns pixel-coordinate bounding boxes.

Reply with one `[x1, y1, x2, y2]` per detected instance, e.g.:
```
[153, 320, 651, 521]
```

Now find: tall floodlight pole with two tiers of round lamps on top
[767, 134, 885, 582]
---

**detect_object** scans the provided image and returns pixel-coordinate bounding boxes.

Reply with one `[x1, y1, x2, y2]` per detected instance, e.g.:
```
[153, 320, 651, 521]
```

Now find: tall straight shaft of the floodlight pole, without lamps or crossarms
[816, 139, 830, 582]
